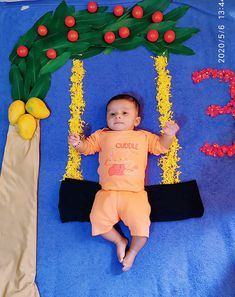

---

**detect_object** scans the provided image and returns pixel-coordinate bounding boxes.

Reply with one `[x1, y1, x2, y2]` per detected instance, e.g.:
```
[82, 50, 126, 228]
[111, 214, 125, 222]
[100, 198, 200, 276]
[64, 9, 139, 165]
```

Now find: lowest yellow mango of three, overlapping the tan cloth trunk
[17, 113, 37, 140]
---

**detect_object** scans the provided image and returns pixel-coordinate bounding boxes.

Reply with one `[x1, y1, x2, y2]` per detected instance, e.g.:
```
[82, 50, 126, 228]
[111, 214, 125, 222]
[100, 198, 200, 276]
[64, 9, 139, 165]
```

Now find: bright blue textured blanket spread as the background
[0, 0, 235, 297]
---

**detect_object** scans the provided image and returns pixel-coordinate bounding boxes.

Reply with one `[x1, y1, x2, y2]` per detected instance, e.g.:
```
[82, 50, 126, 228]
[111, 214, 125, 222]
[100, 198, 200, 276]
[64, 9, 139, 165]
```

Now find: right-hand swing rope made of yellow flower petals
[153, 56, 181, 184]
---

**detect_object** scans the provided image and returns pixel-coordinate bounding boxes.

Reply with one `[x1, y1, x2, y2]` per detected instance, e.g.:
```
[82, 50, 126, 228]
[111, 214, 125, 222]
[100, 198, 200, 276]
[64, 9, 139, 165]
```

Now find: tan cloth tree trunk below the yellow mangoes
[0, 122, 40, 297]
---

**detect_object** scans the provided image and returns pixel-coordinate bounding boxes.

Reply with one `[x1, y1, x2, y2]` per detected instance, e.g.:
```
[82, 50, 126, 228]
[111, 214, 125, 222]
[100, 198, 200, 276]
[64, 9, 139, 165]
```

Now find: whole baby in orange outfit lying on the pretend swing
[68, 94, 179, 271]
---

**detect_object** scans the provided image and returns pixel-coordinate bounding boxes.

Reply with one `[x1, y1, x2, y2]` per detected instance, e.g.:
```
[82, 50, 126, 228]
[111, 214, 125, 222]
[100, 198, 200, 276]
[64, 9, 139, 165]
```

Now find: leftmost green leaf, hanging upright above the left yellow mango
[9, 64, 25, 101]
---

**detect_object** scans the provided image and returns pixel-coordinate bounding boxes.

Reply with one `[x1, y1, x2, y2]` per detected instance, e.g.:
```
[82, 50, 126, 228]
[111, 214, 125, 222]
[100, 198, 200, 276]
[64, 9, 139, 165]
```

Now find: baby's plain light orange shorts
[90, 190, 151, 237]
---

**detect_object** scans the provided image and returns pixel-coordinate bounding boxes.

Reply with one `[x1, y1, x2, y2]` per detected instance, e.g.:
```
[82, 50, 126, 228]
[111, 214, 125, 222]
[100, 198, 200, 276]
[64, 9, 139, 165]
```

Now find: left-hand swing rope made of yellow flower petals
[63, 60, 85, 180]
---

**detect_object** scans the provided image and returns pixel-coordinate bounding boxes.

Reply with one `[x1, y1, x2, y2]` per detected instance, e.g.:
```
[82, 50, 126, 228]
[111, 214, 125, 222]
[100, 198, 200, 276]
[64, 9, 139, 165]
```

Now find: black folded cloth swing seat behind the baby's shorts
[59, 178, 204, 223]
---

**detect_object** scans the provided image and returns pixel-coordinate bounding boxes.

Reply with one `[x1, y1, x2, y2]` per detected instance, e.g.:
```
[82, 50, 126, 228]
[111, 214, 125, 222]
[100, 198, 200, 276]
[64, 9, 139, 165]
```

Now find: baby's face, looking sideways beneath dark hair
[107, 99, 141, 131]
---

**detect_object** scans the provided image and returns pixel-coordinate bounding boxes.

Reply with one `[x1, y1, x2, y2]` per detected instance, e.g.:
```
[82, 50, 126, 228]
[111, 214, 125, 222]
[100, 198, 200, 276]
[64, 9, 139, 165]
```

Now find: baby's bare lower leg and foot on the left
[101, 228, 128, 263]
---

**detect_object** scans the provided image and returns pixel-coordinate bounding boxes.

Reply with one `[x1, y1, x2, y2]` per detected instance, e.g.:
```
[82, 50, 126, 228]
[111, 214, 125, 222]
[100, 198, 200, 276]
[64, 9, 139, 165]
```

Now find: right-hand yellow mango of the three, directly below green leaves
[25, 97, 50, 119]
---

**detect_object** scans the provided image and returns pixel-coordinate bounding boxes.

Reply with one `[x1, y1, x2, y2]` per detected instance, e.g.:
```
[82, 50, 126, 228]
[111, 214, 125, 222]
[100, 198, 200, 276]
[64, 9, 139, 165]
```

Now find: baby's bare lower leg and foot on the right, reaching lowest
[122, 236, 148, 271]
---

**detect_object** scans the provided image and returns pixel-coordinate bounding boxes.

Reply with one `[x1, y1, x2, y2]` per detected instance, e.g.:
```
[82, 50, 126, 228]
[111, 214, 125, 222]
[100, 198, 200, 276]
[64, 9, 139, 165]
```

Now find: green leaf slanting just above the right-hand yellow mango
[27, 73, 51, 99]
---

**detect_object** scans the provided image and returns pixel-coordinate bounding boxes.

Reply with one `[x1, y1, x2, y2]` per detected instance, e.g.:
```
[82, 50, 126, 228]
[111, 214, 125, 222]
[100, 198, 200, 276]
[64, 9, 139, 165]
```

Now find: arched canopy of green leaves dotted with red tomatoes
[10, 0, 199, 114]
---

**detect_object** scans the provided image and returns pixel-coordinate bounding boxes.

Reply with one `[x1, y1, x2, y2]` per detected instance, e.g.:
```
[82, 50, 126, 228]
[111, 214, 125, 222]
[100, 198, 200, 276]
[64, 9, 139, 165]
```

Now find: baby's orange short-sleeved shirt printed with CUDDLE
[83, 129, 167, 192]
